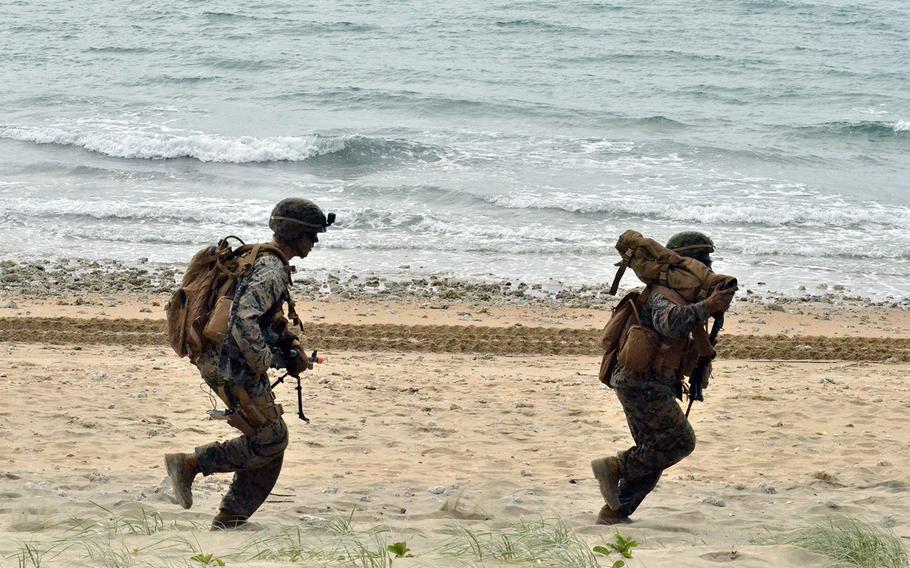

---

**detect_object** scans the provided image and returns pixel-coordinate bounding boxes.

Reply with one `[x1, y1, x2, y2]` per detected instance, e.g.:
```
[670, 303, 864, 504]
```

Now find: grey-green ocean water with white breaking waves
[0, 0, 910, 297]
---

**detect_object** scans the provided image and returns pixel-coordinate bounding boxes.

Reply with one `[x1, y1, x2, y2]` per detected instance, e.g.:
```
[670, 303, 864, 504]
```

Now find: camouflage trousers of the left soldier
[196, 358, 288, 517]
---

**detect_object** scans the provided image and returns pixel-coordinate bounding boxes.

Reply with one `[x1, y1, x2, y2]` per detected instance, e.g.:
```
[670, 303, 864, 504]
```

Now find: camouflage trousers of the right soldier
[615, 382, 695, 516]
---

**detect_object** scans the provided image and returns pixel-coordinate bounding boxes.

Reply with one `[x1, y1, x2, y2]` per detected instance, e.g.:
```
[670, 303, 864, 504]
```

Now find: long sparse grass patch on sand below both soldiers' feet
[7, 508, 636, 568]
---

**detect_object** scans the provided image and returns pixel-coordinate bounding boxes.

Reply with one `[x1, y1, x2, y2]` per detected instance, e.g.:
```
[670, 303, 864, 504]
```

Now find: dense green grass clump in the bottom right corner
[785, 517, 910, 568]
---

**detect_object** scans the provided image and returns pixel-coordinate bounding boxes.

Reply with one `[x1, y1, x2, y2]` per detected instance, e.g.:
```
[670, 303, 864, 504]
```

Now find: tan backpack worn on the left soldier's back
[164, 236, 288, 362]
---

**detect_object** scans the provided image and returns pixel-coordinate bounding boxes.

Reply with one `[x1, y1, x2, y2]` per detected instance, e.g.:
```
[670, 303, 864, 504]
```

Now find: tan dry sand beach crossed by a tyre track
[0, 296, 910, 567]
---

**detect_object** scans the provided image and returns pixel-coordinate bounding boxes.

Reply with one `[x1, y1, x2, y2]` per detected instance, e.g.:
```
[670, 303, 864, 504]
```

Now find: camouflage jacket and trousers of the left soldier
[196, 254, 290, 517]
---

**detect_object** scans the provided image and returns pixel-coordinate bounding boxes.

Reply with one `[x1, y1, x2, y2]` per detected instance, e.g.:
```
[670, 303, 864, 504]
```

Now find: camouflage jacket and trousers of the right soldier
[610, 292, 708, 516]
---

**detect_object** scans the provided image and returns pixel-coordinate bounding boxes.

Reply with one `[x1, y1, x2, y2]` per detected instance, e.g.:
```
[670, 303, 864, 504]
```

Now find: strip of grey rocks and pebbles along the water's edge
[0, 258, 910, 311]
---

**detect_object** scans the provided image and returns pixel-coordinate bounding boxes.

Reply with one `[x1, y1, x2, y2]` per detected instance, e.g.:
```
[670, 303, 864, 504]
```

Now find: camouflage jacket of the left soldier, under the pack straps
[218, 254, 291, 385]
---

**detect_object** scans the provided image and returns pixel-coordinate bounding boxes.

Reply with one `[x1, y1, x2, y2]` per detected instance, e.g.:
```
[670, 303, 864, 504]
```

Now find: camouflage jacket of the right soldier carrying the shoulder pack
[610, 292, 708, 386]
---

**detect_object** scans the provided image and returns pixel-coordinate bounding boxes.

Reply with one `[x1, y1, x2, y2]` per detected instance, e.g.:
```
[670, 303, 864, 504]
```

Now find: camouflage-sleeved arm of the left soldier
[229, 256, 288, 373]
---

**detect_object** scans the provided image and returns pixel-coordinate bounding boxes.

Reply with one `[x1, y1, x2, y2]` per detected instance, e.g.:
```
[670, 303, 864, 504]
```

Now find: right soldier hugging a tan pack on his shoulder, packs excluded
[591, 232, 734, 524]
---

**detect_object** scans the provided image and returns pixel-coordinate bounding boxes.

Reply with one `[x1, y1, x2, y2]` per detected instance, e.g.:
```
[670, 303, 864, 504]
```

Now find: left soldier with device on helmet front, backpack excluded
[165, 198, 334, 530]
